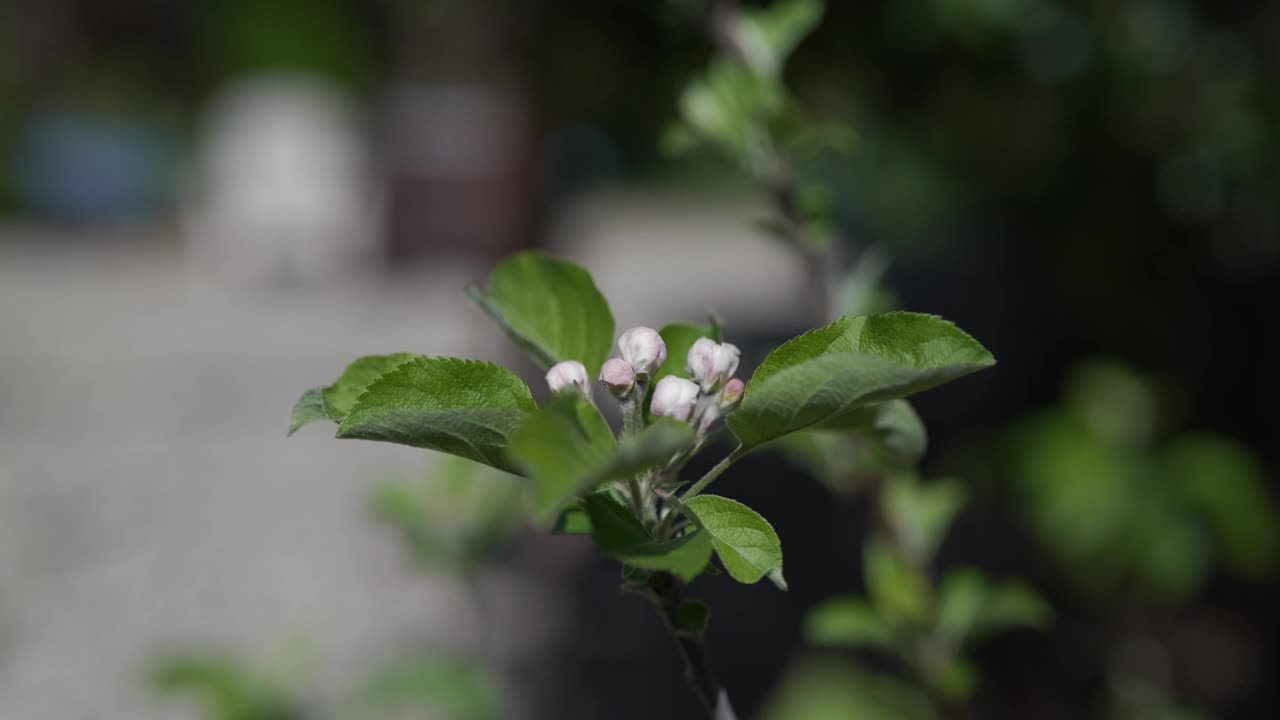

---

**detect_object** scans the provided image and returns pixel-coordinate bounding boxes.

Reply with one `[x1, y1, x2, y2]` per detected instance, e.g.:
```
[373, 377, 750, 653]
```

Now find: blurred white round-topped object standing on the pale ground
[183, 73, 381, 282]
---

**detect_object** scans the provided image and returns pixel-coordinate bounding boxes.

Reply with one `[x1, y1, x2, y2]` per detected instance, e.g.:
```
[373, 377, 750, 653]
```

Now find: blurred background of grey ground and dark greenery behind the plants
[0, 0, 1280, 720]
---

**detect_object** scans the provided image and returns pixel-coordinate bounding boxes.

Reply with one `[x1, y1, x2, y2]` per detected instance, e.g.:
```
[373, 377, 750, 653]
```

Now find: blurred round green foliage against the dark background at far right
[1010, 361, 1280, 600]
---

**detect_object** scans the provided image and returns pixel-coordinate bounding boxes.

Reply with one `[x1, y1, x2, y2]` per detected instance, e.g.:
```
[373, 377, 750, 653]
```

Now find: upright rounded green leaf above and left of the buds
[467, 251, 613, 378]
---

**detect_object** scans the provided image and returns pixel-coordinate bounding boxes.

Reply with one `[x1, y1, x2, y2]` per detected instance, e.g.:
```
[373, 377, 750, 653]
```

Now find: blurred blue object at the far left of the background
[8, 110, 177, 222]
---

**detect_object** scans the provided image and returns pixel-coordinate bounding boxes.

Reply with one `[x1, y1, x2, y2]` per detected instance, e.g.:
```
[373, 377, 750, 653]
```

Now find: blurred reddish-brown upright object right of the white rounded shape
[384, 0, 539, 260]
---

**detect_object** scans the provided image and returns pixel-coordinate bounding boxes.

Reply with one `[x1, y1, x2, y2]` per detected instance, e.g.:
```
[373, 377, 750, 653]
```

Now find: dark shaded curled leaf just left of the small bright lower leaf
[582, 492, 712, 583]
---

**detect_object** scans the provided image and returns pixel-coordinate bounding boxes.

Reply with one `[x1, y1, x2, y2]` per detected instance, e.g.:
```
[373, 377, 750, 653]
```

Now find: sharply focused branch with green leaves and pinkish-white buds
[291, 243, 995, 717]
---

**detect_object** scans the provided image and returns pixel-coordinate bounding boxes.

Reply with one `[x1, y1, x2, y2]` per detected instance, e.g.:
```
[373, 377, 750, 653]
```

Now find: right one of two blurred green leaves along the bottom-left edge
[352, 657, 506, 720]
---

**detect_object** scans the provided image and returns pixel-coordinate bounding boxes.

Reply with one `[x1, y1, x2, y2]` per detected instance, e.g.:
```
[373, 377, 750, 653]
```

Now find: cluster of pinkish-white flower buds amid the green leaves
[547, 327, 746, 432]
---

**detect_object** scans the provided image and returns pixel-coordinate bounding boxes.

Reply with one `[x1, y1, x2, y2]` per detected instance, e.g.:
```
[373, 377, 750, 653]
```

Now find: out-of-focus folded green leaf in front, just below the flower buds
[509, 395, 694, 523]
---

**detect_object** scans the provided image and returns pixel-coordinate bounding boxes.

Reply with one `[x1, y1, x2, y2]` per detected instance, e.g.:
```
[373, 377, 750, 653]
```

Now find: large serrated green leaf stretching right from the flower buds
[728, 313, 995, 448]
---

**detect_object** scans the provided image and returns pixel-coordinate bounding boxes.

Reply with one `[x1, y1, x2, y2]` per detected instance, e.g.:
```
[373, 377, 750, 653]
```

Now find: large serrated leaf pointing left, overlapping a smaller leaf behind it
[338, 357, 536, 471]
